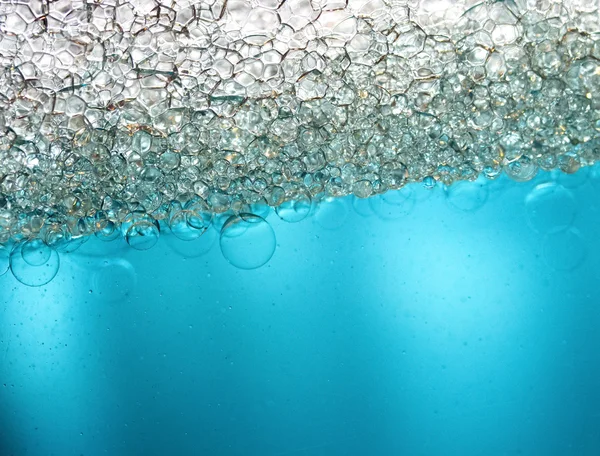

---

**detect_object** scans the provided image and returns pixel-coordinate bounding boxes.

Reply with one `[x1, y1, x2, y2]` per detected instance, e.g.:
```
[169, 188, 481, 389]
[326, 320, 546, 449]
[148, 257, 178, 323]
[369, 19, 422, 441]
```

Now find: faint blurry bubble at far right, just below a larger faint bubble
[543, 228, 586, 271]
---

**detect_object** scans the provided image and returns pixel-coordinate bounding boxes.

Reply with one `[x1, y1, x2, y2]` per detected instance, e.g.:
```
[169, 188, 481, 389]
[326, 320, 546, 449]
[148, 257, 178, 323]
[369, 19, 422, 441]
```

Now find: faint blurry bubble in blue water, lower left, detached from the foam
[92, 258, 137, 302]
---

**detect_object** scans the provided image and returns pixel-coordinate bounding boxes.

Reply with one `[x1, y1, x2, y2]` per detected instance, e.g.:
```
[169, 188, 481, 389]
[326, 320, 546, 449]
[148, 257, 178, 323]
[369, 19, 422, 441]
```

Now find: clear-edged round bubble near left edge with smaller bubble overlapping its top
[10, 241, 60, 287]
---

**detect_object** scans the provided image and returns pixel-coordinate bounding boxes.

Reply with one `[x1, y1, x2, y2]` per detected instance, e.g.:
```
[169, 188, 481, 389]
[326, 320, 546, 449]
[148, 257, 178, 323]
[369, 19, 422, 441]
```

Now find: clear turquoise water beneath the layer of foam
[0, 168, 600, 456]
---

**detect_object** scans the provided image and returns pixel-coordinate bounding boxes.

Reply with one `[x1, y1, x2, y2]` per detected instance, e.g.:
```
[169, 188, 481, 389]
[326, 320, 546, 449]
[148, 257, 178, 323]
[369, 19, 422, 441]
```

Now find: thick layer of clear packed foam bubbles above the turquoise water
[0, 0, 600, 246]
